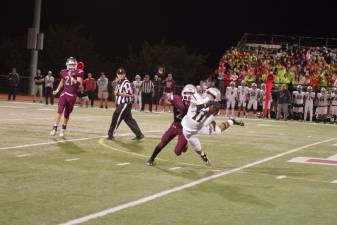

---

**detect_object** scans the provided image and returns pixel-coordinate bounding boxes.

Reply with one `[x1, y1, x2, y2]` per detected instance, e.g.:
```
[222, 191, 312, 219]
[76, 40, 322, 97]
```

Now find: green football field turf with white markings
[0, 101, 337, 225]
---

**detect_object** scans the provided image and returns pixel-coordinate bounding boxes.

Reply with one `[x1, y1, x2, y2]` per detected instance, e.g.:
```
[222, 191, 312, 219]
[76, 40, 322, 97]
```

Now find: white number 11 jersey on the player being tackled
[181, 93, 212, 132]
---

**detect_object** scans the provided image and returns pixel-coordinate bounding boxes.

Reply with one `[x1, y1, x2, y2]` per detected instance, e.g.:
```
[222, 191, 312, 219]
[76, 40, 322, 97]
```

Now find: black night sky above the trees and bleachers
[0, 0, 337, 65]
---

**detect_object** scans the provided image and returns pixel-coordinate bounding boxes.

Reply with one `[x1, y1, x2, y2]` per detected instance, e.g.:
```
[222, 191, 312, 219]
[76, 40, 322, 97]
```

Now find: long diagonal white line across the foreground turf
[59, 138, 337, 225]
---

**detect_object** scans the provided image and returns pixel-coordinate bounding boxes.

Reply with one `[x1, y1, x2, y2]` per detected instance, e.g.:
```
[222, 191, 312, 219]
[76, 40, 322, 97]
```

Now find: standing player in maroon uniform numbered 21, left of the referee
[50, 57, 84, 137]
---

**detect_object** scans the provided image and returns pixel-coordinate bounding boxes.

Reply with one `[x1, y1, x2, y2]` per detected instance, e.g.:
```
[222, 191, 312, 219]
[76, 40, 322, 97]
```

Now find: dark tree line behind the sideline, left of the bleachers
[0, 26, 209, 84]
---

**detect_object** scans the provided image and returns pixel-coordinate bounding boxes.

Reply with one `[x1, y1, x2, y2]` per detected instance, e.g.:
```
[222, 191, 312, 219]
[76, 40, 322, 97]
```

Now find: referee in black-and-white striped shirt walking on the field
[107, 68, 144, 140]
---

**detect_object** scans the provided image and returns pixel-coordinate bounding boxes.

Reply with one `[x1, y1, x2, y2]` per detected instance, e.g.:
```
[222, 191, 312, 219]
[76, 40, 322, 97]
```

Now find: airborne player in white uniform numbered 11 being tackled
[181, 88, 244, 166]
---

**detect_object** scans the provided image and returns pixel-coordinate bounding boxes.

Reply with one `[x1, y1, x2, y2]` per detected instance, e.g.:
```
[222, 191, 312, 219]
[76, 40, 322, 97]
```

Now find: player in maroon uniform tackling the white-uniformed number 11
[146, 84, 197, 166]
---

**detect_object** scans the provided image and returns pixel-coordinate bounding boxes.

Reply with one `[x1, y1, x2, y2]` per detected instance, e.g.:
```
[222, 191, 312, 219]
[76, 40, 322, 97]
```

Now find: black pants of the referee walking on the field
[108, 103, 143, 137]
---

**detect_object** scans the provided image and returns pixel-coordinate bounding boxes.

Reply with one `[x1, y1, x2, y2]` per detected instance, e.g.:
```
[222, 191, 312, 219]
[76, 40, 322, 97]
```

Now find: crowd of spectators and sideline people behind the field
[4, 44, 337, 121]
